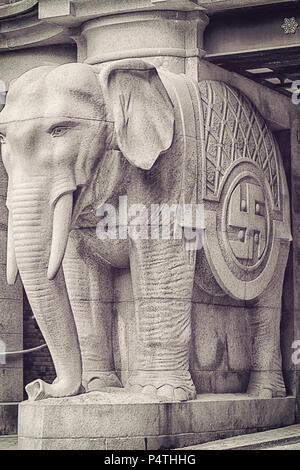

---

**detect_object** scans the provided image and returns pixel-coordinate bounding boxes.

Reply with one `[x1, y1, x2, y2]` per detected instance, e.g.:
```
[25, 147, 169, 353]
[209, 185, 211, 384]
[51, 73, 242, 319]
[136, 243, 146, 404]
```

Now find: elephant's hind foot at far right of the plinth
[247, 371, 286, 398]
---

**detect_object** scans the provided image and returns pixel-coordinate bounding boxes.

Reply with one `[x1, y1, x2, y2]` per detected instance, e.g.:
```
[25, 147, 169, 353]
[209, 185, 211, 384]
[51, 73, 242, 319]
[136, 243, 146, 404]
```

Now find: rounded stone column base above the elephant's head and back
[82, 10, 208, 73]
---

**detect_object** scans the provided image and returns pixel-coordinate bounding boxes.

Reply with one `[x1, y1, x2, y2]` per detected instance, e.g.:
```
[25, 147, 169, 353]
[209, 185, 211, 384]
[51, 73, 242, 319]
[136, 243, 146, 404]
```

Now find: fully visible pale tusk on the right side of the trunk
[47, 193, 73, 281]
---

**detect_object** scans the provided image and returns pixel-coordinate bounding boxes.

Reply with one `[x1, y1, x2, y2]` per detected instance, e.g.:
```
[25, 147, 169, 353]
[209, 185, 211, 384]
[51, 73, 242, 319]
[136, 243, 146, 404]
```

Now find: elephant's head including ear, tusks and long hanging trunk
[0, 60, 174, 396]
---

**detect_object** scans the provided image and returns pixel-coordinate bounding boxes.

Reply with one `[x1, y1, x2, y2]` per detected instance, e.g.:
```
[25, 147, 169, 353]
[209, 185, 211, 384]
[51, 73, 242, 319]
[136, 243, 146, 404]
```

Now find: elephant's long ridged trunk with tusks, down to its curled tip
[8, 177, 81, 399]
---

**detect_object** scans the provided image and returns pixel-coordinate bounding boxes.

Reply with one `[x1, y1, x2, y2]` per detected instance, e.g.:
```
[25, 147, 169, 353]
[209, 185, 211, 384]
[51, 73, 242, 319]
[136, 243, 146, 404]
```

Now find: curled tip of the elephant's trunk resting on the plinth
[25, 379, 85, 401]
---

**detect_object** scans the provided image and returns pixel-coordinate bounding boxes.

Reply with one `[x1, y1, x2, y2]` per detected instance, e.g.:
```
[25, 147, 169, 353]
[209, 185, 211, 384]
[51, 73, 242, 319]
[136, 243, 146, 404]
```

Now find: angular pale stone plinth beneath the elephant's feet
[19, 389, 295, 450]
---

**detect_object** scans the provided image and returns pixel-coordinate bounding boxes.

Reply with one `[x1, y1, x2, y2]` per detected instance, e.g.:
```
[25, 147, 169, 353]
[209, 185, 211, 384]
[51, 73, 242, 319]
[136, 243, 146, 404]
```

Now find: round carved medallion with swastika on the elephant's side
[204, 160, 279, 299]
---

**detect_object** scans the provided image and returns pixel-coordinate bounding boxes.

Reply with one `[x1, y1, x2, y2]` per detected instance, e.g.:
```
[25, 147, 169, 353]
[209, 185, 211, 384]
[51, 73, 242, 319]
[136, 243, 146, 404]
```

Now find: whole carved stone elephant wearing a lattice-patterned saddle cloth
[0, 60, 290, 401]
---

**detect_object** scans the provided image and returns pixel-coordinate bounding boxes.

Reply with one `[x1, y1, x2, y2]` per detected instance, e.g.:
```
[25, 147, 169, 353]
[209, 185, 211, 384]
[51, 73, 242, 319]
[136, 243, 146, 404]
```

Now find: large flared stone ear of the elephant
[99, 60, 174, 170]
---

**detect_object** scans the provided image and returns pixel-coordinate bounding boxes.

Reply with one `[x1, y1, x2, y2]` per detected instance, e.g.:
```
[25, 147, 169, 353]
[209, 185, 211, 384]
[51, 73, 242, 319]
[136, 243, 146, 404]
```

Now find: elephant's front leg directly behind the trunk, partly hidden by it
[63, 230, 122, 391]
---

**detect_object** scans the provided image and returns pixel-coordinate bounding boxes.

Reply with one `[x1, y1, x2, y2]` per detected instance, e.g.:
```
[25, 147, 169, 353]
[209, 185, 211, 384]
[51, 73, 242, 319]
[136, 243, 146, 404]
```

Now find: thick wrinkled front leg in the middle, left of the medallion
[127, 240, 196, 401]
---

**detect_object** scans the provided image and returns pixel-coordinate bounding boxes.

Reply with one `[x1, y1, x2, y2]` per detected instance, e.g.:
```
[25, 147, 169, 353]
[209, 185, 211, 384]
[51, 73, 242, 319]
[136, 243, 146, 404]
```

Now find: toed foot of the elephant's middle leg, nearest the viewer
[126, 370, 196, 402]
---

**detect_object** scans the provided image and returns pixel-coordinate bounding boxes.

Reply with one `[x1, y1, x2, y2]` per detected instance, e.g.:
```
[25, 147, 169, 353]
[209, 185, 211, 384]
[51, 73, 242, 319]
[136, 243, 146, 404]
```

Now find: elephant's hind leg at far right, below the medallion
[247, 244, 289, 398]
